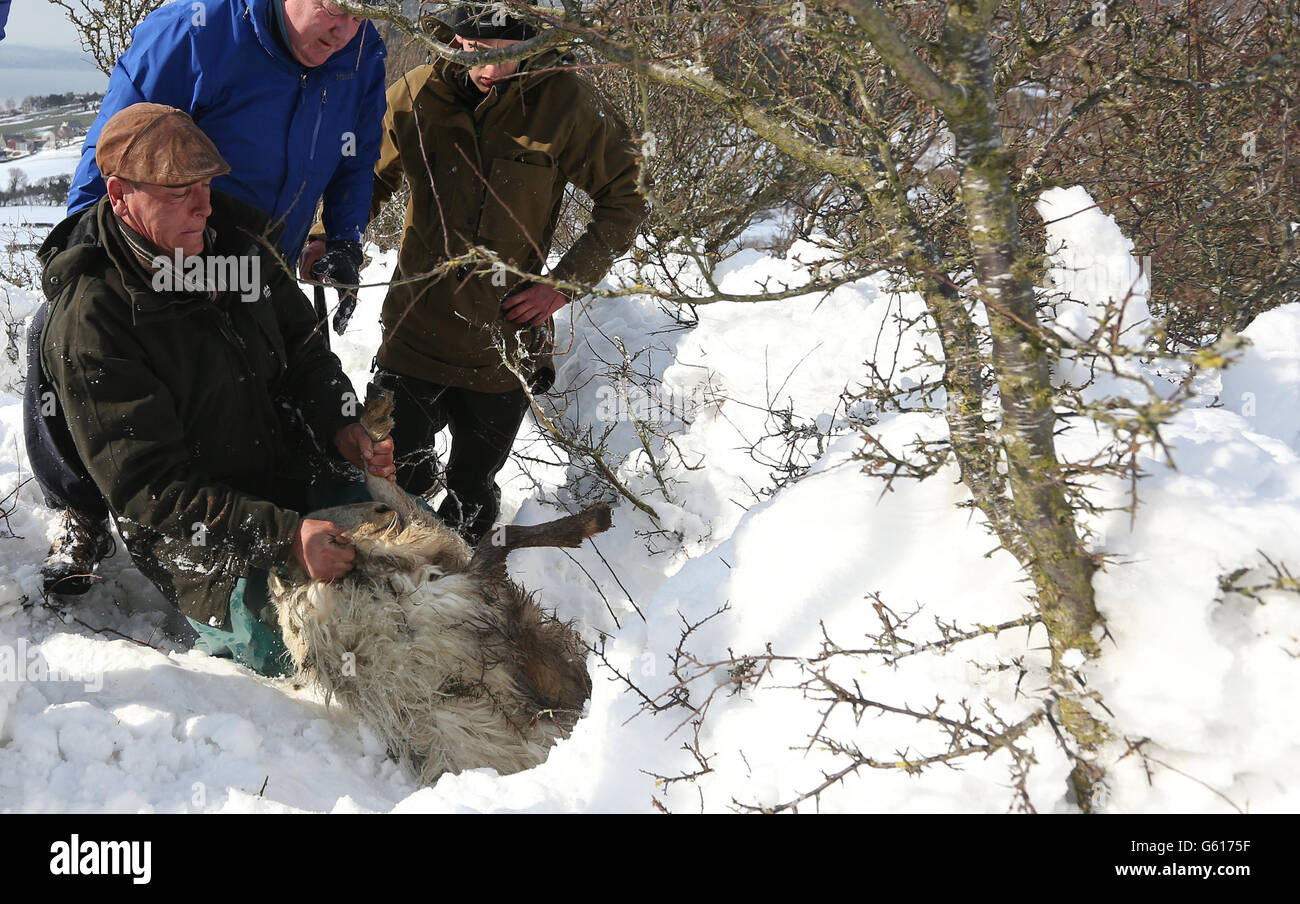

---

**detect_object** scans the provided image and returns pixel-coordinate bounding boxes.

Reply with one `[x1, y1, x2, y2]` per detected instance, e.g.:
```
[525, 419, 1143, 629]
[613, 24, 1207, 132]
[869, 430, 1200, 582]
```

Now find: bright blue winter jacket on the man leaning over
[68, 0, 386, 260]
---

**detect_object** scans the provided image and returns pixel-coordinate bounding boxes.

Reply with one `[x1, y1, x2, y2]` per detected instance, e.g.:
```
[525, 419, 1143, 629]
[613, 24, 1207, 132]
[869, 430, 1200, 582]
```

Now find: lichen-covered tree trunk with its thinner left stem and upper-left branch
[836, 0, 1106, 809]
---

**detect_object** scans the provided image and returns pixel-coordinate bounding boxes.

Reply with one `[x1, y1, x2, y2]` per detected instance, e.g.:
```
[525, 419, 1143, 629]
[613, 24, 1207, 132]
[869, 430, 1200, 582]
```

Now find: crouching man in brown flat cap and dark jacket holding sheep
[39, 104, 393, 674]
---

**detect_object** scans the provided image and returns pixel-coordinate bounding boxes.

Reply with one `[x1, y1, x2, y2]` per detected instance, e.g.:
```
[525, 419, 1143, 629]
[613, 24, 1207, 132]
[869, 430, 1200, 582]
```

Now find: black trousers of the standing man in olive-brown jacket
[378, 371, 528, 544]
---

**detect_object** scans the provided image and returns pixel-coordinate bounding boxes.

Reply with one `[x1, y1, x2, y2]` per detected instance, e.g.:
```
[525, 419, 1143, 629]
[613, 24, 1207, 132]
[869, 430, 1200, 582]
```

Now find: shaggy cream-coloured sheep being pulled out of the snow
[270, 385, 611, 784]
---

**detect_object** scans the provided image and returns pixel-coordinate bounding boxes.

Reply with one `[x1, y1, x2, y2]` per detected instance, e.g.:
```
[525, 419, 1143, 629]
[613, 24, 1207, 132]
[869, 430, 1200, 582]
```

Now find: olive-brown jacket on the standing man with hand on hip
[371, 45, 646, 392]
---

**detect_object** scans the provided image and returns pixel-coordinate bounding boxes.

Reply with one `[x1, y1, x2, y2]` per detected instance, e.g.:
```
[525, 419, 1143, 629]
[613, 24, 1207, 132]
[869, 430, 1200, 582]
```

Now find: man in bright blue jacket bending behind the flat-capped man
[25, 0, 386, 593]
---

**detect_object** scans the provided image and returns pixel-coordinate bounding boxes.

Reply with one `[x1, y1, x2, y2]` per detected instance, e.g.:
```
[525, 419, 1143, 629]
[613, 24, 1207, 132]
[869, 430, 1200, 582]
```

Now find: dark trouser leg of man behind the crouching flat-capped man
[22, 303, 108, 523]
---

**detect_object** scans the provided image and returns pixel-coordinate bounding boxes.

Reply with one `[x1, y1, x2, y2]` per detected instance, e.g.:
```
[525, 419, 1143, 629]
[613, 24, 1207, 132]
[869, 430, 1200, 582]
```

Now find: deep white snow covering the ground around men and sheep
[0, 159, 1300, 812]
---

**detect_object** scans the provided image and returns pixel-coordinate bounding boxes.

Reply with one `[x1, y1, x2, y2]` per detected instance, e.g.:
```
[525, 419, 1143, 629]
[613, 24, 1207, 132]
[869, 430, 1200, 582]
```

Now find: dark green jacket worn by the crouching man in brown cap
[39, 191, 358, 623]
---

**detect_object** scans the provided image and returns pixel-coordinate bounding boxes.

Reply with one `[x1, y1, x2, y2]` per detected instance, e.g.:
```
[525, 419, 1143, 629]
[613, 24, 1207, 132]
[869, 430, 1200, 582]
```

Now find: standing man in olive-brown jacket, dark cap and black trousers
[348, 4, 646, 542]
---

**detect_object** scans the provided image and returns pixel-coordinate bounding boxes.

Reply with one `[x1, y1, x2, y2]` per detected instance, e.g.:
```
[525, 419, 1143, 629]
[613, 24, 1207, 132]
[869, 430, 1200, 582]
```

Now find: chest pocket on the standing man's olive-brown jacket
[478, 157, 558, 264]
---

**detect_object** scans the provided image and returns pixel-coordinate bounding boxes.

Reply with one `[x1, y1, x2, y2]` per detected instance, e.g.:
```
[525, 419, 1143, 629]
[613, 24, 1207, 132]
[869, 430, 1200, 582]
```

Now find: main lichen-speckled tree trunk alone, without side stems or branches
[943, 0, 1106, 809]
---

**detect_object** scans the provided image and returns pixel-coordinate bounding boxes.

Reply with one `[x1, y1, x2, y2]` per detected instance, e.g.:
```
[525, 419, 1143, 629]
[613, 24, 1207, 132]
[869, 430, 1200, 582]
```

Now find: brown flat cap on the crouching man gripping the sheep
[95, 104, 230, 189]
